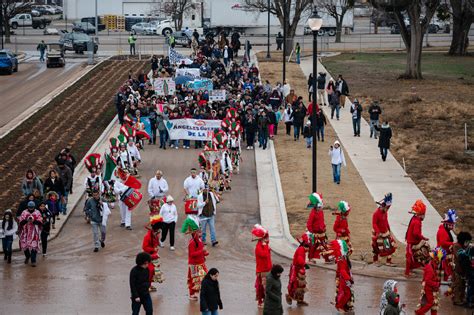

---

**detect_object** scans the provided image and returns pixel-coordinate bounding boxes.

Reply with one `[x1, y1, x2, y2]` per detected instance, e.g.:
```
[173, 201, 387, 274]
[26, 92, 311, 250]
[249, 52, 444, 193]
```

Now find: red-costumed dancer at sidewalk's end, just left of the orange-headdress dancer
[372, 193, 397, 266]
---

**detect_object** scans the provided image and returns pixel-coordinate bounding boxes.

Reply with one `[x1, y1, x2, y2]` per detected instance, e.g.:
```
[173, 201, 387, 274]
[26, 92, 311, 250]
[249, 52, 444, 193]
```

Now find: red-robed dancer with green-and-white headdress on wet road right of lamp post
[329, 240, 354, 313]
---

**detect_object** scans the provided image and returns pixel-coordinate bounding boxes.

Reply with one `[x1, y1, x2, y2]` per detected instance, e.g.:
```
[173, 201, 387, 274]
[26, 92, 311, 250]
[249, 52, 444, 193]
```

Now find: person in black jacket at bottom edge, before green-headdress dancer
[199, 268, 223, 315]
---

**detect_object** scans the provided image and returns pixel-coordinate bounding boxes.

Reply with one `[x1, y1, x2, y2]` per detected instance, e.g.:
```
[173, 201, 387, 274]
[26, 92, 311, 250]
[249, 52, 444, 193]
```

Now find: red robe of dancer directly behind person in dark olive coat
[255, 240, 272, 304]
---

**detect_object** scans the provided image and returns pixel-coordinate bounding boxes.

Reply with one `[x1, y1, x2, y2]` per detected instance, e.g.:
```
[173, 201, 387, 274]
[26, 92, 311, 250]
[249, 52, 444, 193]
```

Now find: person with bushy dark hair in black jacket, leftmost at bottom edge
[130, 253, 153, 315]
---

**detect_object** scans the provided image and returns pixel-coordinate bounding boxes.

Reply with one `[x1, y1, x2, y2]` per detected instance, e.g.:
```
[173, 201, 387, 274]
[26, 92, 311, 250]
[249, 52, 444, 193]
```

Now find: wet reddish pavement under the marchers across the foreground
[0, 146, 471, 315]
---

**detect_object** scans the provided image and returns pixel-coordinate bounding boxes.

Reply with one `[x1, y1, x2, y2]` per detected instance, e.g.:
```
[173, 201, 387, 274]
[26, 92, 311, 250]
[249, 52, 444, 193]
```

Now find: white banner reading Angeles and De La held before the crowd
[166, 119, 221, 141]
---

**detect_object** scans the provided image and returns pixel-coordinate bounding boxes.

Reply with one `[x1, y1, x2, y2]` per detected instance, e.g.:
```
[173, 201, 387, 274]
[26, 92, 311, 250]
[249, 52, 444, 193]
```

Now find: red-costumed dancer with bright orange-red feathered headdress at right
[405, 200, 430, 277]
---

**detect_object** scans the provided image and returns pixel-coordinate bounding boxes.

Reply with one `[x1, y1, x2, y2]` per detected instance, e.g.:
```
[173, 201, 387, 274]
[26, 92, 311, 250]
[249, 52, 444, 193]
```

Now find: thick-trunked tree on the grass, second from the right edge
[369, 0, 440, 79]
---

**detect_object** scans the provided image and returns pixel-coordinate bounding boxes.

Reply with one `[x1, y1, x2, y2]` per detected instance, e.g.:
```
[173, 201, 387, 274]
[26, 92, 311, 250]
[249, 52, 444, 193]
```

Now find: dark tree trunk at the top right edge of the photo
[438, 0, 474, 56]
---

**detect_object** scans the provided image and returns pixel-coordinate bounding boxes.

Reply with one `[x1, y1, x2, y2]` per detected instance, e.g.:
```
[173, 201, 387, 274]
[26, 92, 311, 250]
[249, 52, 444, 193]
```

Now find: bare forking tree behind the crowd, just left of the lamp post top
[242, 0, 313, 54]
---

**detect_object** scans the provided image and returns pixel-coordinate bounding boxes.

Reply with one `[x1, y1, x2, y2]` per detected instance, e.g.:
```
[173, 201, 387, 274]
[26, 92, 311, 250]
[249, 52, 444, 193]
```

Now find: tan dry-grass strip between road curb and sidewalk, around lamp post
[259, 54, 405, 265]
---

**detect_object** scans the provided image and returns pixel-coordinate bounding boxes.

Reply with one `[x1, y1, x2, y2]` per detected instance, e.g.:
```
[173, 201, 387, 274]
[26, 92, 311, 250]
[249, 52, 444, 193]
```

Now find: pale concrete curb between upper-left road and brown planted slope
[0, 56, 112, 139]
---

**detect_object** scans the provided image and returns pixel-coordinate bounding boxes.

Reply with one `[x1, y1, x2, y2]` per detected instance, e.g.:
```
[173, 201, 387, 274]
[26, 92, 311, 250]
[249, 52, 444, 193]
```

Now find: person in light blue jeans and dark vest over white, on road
[198, 188, 219, 247]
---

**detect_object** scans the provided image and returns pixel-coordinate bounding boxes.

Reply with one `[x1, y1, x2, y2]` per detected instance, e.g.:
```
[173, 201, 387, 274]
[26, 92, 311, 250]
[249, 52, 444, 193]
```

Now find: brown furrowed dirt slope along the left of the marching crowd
[0, 60, 145, 211]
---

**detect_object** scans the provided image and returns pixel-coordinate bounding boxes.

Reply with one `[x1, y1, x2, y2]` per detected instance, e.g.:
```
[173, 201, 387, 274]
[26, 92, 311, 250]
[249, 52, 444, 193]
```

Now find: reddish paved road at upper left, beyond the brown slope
[0, 61, 83, 128]
